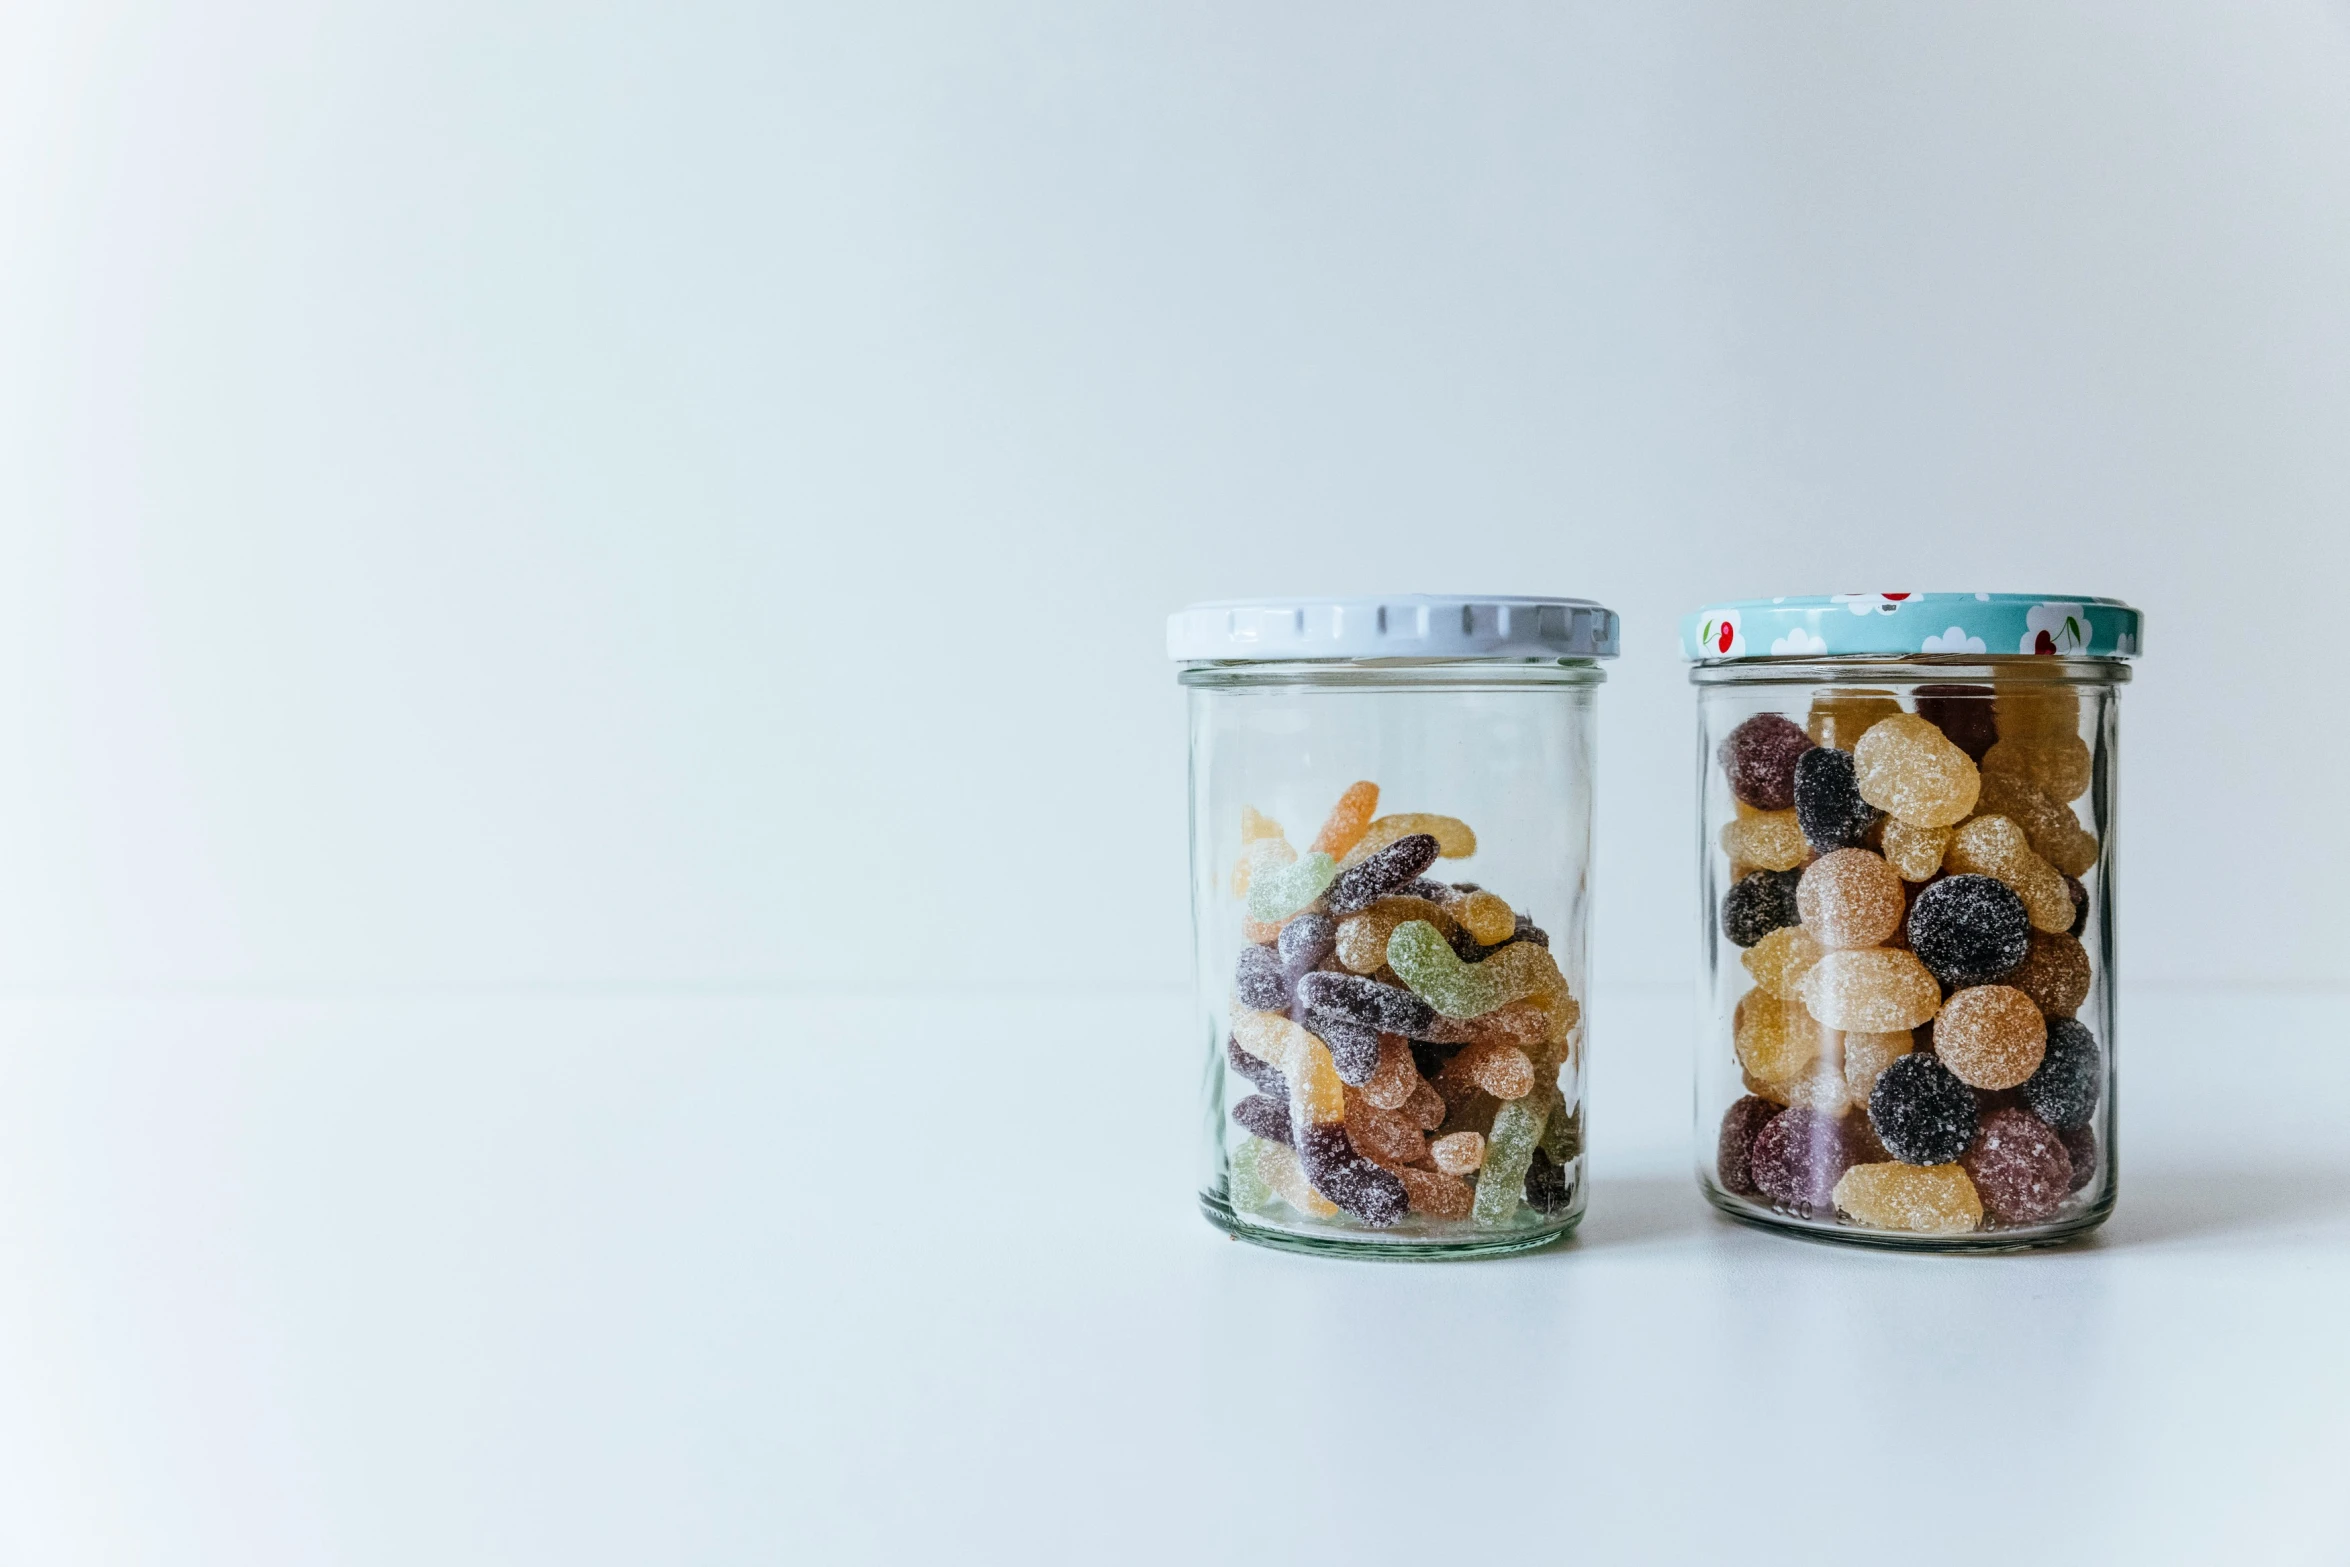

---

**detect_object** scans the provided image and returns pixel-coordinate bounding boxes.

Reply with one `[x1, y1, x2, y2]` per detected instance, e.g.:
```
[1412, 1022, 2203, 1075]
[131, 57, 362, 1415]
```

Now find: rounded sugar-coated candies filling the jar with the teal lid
[1716, 686, 2106, 1233]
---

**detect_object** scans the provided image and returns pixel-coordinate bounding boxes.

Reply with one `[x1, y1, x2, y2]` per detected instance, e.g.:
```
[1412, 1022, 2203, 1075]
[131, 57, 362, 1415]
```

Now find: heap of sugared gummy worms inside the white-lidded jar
[1224, 782, 1582, 1236]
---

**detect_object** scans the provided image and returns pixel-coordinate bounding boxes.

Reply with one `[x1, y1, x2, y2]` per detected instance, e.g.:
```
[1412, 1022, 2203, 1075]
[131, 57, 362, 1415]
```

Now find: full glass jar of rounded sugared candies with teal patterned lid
[1683, 592, 2139, 1250]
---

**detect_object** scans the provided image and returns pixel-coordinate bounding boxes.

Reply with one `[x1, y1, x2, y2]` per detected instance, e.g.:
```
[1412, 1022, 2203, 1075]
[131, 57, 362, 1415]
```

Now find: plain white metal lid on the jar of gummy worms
[1168, 592, 1617, 663]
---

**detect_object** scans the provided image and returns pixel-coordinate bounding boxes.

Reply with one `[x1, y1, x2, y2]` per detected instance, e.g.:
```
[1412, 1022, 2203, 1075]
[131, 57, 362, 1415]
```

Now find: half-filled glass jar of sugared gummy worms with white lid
[1168, 594, 1617, 1257]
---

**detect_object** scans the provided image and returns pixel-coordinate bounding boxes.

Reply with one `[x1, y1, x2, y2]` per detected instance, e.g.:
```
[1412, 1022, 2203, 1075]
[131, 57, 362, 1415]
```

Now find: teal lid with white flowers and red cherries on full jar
[1680, 592, 2141, 663]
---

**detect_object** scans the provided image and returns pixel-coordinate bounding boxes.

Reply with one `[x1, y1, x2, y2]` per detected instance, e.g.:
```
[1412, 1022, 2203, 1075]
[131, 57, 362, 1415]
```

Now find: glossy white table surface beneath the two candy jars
[0, 989, 2350, 1567]
